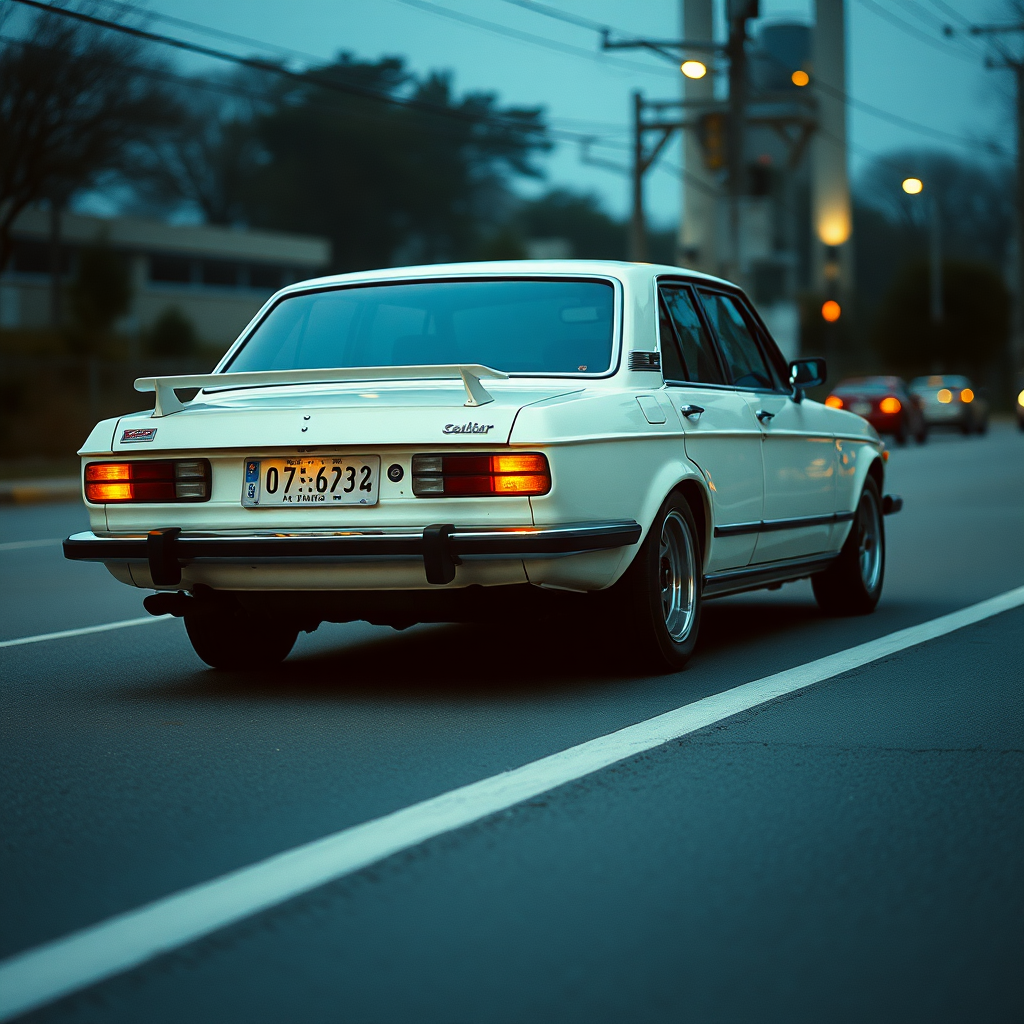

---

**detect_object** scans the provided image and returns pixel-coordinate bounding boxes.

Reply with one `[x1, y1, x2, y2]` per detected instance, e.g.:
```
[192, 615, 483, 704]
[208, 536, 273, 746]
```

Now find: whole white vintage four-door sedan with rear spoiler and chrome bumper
[65, 260, 900, 669]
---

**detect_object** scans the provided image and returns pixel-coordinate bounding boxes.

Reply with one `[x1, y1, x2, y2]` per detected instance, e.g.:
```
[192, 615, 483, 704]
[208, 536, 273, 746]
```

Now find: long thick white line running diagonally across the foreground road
[0, 587, 1024, 1021]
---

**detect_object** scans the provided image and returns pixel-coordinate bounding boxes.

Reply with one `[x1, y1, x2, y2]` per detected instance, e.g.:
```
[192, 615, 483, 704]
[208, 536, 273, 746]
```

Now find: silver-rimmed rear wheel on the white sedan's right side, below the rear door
[615, 494, 703, 672]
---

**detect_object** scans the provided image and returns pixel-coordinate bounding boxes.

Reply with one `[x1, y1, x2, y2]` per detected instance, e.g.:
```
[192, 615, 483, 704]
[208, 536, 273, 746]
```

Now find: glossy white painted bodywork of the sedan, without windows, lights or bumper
[66, 260, 882, 606]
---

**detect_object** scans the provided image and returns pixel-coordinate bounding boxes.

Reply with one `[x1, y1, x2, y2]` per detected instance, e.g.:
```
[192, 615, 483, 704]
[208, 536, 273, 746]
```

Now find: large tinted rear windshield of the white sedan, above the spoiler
[227, 278, 614, 374]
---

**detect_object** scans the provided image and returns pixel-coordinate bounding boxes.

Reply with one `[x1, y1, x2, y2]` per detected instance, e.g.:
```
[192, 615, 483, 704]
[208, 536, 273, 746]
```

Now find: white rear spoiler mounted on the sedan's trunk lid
[135, 362, 509, 417]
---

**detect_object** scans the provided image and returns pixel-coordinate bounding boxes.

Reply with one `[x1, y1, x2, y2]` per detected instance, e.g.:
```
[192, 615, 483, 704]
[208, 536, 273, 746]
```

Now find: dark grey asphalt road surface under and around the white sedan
[0, 427, 1024, 1022]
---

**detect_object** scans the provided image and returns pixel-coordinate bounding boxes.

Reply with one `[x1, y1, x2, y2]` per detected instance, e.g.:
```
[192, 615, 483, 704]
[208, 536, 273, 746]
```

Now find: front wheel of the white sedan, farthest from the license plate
[811, 477, 886, 615]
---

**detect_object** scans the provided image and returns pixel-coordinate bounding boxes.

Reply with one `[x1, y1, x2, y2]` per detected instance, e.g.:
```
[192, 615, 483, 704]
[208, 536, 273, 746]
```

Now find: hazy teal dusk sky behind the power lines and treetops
[114, 0, 1013, 225]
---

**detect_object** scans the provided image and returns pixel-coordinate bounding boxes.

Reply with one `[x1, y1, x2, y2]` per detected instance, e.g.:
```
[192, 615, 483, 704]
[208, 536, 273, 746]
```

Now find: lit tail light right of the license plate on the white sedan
[413, 453, 551, 498]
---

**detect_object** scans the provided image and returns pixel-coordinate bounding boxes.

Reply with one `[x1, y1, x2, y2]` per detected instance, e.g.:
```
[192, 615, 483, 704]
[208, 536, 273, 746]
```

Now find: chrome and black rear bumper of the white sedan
[63, 520, 641, 587]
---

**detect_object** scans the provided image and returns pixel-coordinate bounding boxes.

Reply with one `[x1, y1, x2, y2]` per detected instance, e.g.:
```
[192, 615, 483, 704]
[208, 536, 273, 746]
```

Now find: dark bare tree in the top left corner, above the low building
[0, 2, 178, 280]
